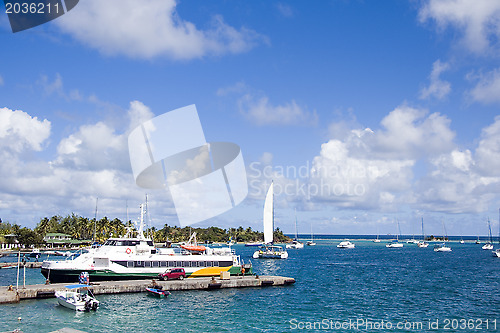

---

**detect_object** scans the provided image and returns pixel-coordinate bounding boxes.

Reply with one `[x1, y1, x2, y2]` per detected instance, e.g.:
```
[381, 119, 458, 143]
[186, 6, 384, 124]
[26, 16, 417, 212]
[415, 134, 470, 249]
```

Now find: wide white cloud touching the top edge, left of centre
[56, 0, 266, 59]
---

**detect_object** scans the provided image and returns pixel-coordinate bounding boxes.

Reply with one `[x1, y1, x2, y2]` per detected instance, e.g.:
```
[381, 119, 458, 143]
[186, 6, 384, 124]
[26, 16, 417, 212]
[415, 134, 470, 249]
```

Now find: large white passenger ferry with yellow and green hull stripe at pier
[41, 205, 252, 282]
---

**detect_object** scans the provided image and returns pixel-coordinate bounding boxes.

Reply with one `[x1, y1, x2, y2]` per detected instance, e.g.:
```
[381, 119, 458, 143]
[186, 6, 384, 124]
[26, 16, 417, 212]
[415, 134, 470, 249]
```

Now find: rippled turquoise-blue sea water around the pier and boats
[0, 239, 500, 332]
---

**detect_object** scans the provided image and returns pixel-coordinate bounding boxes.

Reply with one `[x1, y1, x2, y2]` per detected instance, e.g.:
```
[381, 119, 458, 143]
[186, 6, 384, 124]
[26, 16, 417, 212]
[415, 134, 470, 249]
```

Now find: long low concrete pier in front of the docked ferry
[0, 275, 295, 304]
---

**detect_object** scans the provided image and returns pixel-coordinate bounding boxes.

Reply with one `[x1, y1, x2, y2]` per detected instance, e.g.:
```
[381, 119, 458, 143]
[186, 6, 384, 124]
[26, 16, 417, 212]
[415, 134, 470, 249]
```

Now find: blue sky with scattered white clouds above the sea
[0, 0, 500, 235]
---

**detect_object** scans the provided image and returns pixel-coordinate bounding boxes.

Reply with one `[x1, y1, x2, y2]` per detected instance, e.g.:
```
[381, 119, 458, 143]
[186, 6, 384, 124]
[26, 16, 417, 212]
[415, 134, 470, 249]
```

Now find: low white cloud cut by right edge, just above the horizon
[415, 117, 500, 213]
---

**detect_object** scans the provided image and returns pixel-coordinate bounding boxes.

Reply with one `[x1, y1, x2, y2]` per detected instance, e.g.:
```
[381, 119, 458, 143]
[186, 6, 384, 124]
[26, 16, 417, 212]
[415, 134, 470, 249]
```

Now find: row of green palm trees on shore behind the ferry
[0, 214, 291, 245]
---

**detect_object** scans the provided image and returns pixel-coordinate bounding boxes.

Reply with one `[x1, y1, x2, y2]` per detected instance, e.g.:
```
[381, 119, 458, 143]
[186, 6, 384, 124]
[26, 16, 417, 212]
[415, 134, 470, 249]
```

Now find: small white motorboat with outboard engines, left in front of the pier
[55, 284, 99, 311]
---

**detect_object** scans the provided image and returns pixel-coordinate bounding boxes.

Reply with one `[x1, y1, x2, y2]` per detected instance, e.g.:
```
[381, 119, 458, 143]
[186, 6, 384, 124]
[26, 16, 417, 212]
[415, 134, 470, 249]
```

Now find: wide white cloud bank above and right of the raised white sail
[248, 105, 460, 211]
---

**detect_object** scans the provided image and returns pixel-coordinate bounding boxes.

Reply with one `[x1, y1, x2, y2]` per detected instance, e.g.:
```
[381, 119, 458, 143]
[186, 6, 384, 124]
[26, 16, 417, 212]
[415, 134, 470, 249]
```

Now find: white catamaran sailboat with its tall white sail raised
[253, 182, 288, 259]
